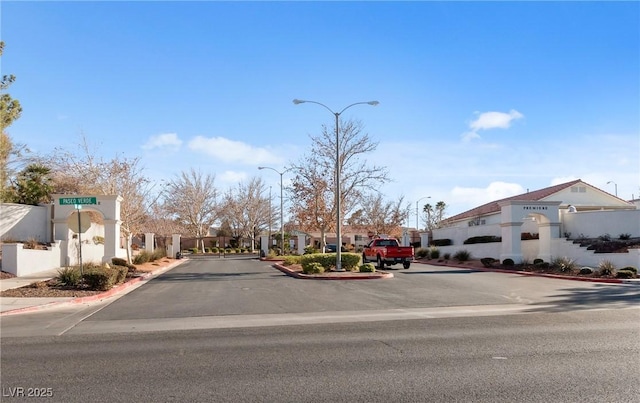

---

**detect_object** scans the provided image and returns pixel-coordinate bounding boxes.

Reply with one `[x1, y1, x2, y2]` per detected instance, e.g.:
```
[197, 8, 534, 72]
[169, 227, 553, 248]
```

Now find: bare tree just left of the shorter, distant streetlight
[220, 177, 270, 251]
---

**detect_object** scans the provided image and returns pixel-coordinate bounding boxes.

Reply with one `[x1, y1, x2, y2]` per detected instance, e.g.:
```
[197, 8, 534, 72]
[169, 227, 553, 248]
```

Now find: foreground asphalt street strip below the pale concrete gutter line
[2, 309, 640, 403]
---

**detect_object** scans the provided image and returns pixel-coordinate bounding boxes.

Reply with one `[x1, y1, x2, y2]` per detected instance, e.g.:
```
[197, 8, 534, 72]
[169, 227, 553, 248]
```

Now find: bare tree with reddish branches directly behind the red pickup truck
[347, 193, 407, 238]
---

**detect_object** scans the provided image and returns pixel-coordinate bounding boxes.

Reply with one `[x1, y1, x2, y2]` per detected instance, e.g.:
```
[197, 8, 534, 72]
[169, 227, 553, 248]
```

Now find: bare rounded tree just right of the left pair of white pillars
[164, 168, 219, 250]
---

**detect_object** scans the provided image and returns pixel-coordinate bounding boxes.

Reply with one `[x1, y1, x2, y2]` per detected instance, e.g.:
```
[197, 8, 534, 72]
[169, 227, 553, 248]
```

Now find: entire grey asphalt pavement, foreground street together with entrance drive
[0, 260, 640, 402]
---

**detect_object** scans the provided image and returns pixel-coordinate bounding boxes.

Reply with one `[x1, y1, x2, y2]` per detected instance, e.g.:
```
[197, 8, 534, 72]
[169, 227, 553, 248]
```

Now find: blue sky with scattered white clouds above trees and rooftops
[0, 1, 640, 222]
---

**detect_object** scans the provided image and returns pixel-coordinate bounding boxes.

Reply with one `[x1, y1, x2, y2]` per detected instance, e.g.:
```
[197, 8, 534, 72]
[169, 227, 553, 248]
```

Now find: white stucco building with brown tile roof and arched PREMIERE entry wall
[431, 179, 640, 267]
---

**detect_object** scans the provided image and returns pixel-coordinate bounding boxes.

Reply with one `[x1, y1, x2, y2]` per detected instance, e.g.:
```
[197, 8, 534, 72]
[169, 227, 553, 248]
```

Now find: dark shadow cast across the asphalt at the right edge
[528, 284, 640, 312]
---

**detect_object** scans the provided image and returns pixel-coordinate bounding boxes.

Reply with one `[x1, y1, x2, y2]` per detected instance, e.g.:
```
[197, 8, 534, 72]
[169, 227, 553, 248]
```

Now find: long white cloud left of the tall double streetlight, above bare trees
[189, 136, 282, 165]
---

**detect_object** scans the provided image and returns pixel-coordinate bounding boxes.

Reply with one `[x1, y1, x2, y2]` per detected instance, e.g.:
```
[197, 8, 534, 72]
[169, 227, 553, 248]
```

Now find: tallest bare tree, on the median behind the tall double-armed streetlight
[290, 120, 389, 246]
